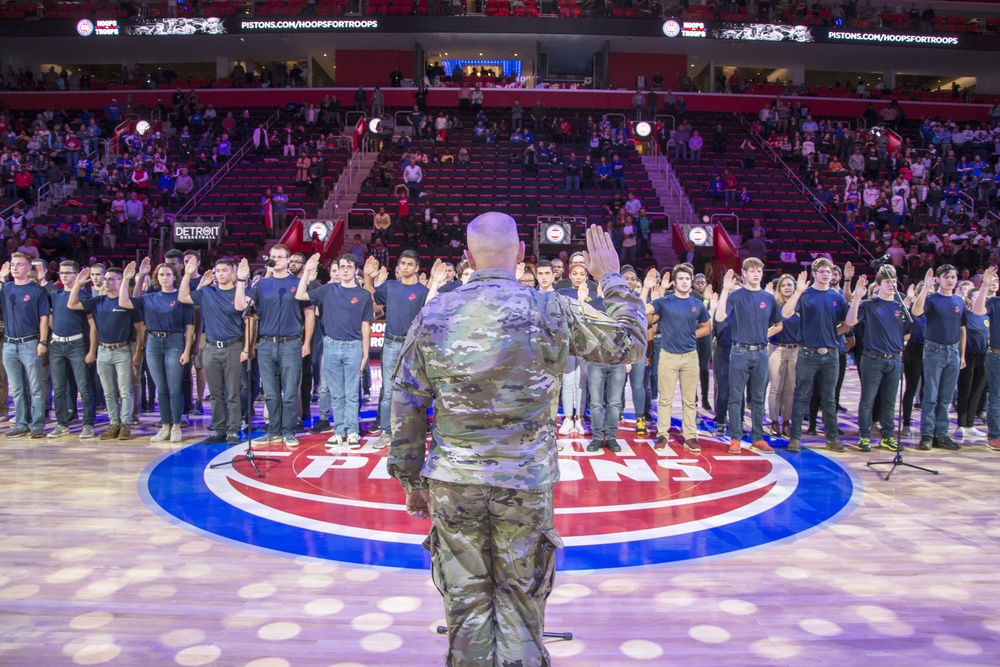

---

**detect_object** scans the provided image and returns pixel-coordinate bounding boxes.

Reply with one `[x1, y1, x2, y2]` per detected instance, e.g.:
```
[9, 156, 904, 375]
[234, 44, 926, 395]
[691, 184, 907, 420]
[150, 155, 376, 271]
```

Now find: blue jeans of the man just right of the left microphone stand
[257, 339, 302, 438]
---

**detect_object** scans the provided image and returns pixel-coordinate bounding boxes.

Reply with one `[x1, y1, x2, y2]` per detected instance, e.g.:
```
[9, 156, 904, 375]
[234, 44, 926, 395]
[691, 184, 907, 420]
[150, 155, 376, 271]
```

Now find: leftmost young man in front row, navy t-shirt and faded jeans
[0, 252, 52, 438]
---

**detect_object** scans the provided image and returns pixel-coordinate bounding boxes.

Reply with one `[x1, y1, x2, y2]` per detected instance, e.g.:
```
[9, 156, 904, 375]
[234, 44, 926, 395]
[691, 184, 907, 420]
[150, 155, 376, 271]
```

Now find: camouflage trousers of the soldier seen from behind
[424, 480, 562, 667]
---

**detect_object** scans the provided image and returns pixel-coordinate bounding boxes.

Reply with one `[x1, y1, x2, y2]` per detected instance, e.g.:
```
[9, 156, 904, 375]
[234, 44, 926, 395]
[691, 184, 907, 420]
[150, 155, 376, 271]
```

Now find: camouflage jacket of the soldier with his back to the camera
[388, 269, 646, 492]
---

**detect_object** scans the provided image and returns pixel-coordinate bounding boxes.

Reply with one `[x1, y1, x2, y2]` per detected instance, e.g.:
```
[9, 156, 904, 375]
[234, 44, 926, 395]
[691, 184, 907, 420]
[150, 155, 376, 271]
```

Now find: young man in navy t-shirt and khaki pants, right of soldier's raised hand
[643, 264, 712, 453]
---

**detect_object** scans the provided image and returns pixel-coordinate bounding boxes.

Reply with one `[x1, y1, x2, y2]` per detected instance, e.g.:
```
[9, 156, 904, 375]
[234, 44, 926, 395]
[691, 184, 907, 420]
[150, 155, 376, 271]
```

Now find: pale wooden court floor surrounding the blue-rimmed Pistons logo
[0, 370, 1000, 667]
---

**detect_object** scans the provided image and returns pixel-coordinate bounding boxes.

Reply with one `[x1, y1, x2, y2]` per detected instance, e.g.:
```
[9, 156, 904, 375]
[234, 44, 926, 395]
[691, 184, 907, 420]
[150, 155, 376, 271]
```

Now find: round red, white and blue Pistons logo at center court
[140, 436, 859, 571]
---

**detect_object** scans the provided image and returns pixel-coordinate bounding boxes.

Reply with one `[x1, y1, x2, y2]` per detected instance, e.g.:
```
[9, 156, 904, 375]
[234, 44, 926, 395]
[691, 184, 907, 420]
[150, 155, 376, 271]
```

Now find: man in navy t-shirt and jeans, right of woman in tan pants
[781, 257, 848, 452]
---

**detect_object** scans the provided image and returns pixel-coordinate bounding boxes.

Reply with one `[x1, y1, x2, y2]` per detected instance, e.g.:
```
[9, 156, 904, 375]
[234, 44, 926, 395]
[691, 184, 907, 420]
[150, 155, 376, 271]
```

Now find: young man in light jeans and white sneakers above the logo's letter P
[295, 253, 375, 448]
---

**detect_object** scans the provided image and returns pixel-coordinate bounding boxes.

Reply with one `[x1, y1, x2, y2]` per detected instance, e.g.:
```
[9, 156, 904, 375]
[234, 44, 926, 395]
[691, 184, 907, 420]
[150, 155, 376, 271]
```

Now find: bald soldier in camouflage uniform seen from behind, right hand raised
[388, 213, 646, 667]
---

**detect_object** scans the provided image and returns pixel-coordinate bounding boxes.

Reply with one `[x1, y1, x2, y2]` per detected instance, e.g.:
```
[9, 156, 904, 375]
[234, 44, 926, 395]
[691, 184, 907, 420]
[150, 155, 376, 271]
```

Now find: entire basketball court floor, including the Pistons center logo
[0, 368, 1000, 667]
